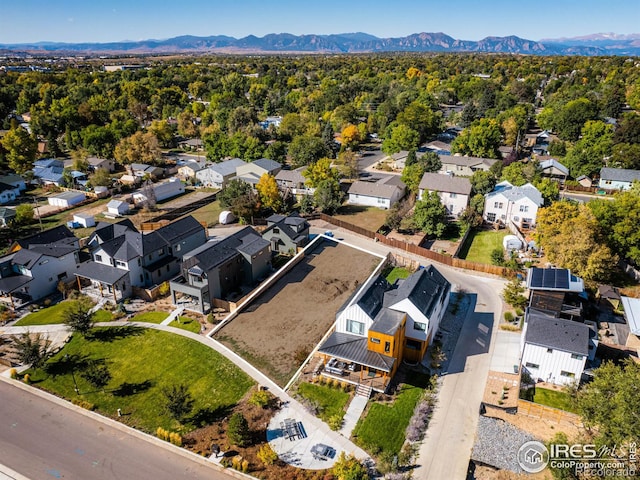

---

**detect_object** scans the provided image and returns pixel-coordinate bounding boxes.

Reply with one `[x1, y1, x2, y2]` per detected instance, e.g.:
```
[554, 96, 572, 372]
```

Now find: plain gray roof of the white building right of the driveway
[525, 311, 590, 356]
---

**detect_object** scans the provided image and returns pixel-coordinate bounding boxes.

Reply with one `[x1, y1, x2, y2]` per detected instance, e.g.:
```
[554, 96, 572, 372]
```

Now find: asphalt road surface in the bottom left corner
[0, 381, 232, 480]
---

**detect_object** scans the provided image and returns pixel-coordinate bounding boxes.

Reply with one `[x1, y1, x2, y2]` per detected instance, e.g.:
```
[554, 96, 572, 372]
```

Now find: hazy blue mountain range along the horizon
[0, 32, 640, 56]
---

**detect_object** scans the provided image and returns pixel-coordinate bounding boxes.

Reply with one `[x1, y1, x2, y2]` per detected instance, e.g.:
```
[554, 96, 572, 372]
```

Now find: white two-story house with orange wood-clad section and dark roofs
[318, 265, 451, 392]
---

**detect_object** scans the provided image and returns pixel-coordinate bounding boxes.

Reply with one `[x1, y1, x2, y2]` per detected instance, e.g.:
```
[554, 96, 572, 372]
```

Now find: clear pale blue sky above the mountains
[0, 0, 640, 43]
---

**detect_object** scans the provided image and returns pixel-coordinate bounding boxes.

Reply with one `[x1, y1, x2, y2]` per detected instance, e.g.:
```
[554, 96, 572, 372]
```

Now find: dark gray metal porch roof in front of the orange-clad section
[318, 332, 396, 372]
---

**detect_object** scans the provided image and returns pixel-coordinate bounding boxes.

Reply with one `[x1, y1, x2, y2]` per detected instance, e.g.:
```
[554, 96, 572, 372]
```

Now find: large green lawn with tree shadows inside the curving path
[28, 326, 254, 433]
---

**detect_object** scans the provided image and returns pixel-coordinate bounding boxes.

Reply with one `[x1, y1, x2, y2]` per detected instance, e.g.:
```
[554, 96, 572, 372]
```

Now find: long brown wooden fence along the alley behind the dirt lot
[318, 213, 516, 278]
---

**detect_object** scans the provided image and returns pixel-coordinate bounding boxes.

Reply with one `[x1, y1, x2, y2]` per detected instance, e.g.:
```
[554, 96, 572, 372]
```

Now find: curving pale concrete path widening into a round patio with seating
[0, 321, 370, 469]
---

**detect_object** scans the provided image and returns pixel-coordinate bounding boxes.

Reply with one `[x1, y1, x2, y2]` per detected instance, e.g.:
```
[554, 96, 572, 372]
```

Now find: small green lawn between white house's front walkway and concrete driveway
[353, 376, 428, 455]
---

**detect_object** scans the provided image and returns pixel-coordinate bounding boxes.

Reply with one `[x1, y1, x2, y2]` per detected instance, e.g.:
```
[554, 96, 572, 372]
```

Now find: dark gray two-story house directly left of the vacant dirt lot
[170, 227, 271, 313]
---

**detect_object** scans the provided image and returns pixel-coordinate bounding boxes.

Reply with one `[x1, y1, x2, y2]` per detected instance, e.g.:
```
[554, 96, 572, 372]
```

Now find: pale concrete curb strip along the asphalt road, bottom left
[0, 375, 256, 480]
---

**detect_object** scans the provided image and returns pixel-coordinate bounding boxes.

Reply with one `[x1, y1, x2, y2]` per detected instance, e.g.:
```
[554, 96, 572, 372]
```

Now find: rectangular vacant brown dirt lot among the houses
[215, 241, 381, 386]
